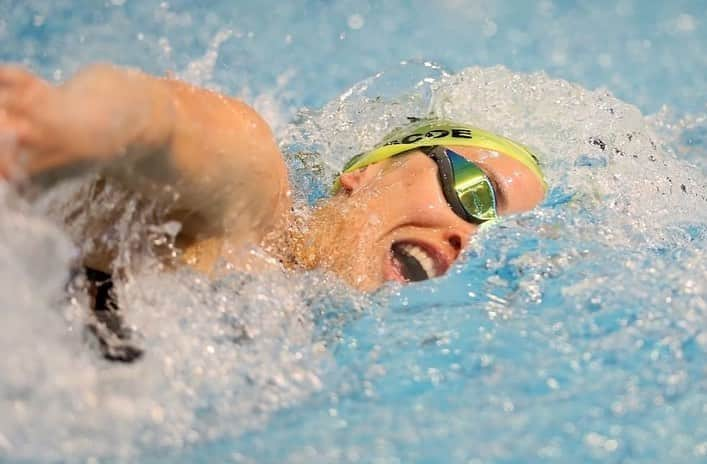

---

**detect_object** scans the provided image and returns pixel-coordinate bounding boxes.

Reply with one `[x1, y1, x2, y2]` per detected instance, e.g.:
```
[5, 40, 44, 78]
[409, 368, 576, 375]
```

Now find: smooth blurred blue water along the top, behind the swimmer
[0, 0, 707, 114]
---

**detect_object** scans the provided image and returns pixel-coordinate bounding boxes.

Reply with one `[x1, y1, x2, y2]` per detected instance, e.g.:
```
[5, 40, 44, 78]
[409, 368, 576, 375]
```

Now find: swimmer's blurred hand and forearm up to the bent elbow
[0, 65, 172, 180]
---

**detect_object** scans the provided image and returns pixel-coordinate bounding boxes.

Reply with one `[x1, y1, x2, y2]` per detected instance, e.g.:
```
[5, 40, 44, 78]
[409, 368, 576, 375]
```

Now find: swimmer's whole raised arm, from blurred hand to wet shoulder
[0, 65, 289, 243]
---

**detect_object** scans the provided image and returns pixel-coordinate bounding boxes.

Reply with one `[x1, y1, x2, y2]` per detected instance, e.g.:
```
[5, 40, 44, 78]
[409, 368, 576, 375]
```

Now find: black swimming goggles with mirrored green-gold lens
[420, 145, 498, 224]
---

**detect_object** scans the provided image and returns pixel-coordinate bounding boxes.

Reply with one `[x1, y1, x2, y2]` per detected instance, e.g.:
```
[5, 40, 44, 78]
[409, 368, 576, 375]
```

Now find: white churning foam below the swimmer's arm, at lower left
[0, 175, 370, 460]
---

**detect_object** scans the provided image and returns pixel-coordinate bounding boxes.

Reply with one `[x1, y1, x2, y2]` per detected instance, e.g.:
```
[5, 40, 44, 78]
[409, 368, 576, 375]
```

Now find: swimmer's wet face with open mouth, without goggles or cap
[311, 146, 544, 290]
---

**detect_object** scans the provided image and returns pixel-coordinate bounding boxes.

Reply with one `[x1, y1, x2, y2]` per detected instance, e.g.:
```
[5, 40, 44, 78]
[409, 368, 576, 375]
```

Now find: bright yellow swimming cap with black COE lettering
[332, 119, 547, 193]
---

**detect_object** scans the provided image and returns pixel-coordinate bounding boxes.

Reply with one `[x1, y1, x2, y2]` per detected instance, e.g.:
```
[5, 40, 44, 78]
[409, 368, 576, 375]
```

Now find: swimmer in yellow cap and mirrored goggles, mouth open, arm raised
[0, 65, 546, 291]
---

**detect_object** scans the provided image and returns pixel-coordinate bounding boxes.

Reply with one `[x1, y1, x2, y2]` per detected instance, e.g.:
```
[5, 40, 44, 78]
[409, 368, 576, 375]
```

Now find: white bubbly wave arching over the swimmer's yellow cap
[285, 63, 707, 250]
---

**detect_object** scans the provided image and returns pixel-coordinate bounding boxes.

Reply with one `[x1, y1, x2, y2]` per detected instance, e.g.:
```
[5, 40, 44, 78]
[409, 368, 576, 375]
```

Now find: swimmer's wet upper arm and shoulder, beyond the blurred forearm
[118, 68, 289, 240]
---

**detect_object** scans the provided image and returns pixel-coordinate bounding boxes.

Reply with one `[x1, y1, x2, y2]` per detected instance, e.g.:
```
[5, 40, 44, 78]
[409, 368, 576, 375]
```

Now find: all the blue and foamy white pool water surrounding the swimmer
[0, 0, 707, 463]
